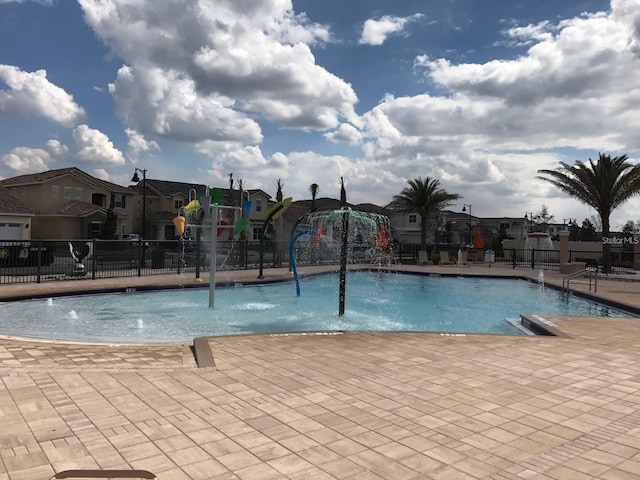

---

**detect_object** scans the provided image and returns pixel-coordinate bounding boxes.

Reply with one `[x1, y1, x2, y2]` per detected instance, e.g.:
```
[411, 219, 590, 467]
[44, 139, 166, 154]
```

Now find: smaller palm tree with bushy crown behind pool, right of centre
[389, 177, 462, 250]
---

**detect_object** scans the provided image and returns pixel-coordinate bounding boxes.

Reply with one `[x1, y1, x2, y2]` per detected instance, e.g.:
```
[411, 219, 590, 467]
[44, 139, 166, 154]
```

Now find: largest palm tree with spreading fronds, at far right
[536, 153, 640, 273]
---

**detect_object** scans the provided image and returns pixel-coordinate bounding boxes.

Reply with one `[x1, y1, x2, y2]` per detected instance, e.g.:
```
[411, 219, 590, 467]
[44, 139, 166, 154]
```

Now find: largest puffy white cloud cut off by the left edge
[0, 65, 86, 127]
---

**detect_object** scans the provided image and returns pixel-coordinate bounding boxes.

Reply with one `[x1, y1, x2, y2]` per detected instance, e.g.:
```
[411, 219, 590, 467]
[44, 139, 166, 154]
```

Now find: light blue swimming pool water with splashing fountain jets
[0, 272, 630, 343]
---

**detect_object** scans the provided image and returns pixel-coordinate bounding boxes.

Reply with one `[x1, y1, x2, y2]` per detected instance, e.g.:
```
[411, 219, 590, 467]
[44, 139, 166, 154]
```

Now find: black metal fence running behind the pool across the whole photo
[0, 240, 634, 284]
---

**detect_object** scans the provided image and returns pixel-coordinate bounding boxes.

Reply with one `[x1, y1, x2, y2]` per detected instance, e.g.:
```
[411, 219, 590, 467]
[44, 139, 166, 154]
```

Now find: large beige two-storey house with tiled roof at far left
[0, 167, 137, 239]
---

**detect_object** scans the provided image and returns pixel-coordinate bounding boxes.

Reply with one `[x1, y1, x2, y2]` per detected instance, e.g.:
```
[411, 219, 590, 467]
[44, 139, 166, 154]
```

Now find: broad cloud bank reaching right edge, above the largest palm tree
[350, 0, 640, 222]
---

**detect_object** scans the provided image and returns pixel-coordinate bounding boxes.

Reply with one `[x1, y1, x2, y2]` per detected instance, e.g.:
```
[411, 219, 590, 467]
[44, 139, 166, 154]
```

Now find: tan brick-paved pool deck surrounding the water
[0, 265, 640, 480]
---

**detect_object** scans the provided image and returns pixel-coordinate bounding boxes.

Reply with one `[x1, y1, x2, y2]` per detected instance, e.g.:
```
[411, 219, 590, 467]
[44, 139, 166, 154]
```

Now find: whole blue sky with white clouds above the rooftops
[0, 0, 640, 228]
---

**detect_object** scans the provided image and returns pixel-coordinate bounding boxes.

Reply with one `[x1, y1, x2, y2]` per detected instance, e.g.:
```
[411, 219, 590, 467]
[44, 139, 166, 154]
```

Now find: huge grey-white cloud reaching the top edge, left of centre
[80, 0, 357, 139]
